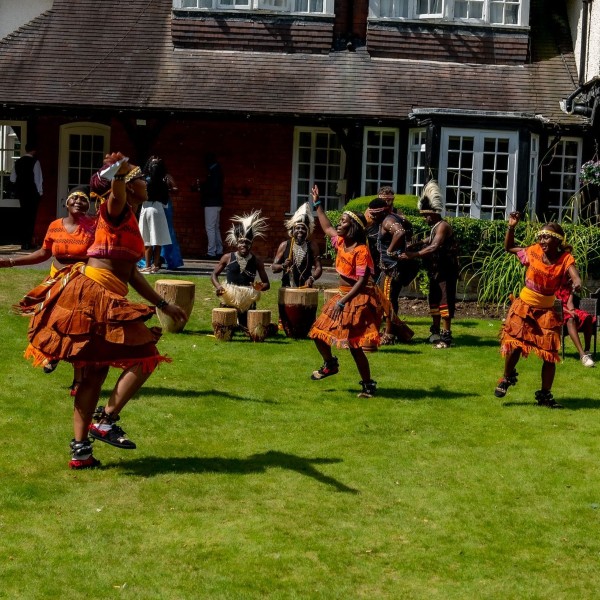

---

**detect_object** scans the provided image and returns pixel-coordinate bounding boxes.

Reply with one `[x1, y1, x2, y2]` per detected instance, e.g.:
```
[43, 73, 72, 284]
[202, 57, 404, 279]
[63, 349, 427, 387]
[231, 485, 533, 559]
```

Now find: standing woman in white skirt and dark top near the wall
[140, 156, 171, 273]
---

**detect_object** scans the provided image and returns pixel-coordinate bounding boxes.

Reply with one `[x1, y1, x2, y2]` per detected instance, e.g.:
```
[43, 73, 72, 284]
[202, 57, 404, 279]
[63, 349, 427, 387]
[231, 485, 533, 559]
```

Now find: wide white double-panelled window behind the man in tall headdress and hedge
[440, 129, 518, 220]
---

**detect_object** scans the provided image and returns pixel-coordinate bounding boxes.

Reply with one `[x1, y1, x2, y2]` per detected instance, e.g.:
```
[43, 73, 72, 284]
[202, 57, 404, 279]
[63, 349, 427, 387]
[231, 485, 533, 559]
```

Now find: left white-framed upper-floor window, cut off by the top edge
[173, 0, 334, 15]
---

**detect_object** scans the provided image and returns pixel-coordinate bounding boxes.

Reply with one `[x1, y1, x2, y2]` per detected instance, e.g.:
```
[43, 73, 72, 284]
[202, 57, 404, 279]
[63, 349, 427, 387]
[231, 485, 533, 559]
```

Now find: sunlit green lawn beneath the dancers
[0, 269, 600, 600]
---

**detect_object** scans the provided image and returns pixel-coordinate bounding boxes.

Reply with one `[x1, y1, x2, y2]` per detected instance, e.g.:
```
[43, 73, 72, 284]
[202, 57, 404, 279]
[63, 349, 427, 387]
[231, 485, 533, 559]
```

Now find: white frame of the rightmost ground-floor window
[546, 137, 583, 223]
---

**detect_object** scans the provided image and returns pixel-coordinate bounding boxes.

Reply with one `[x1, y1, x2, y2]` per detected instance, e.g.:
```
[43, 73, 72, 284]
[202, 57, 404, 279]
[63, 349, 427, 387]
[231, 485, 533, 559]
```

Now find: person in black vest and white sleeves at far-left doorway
[10, 144, 44, 250]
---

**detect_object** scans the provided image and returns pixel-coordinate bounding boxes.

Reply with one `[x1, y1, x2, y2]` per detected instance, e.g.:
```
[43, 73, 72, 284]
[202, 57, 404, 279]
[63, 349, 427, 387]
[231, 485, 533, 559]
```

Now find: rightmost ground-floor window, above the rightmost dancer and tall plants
[545, 138, 581, 222]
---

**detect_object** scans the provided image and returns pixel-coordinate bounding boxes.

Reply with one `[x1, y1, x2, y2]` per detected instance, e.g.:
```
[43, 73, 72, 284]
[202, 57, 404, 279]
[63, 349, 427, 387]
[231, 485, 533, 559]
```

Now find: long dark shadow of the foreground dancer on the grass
[112, 450, 360, 494]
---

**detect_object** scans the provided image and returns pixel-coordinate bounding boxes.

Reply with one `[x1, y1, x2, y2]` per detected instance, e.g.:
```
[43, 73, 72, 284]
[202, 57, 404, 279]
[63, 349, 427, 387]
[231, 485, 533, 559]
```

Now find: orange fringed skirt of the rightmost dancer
[500, 298, 562, 363]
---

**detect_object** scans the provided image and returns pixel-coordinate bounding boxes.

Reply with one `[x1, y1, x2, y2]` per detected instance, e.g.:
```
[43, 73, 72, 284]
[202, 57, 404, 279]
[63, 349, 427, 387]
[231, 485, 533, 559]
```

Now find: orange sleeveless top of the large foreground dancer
[87, 203, 144, 262]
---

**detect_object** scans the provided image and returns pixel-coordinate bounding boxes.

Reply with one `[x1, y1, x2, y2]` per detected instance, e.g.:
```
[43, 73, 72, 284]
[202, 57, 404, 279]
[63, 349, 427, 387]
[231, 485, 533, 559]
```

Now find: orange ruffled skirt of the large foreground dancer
[15, 267, 170, 373]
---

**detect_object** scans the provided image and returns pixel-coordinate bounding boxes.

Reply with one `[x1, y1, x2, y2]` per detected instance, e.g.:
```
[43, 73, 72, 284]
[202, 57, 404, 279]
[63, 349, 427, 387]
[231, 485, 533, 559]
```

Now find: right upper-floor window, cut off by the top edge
[369, 0, 529, 25]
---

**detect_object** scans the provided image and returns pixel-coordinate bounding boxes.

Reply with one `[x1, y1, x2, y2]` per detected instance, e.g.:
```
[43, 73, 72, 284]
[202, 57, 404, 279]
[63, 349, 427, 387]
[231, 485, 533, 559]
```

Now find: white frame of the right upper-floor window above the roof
[369, 0, 530, 27]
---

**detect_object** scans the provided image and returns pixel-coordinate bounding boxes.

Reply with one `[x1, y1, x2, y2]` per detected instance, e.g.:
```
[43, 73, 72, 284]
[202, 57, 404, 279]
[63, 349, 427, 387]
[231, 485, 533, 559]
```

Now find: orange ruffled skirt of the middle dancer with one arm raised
[308, 286, 383, 348]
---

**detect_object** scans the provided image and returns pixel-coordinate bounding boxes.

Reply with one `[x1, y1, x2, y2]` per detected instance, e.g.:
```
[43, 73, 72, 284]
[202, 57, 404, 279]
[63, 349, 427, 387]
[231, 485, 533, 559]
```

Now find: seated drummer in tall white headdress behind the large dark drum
[271, 202, 323, 288]
